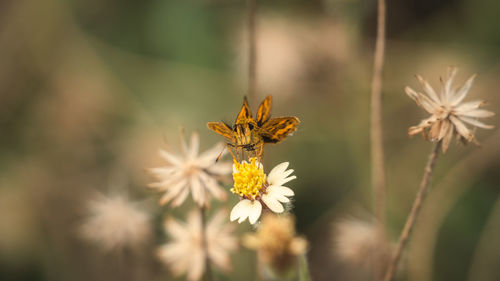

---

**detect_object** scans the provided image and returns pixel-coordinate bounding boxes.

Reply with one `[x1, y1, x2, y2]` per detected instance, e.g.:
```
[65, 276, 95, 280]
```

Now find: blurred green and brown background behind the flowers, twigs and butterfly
[0, 0, 500, 281]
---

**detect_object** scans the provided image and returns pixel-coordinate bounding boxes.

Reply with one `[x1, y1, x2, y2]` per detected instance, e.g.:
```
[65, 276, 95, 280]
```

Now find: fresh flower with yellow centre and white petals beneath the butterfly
[230, 158, 297, 224]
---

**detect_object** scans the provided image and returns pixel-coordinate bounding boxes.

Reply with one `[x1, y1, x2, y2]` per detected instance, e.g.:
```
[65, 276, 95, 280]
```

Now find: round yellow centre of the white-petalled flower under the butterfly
[231, 157, 266, 200]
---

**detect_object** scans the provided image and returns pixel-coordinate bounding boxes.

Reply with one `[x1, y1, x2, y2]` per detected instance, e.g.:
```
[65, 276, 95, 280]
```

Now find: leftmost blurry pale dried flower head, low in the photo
[80, 192, 151, 250]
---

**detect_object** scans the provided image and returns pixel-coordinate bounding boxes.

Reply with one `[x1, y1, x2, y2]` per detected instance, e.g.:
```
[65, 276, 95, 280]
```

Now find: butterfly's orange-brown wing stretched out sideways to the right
[260, 117, 300, 143]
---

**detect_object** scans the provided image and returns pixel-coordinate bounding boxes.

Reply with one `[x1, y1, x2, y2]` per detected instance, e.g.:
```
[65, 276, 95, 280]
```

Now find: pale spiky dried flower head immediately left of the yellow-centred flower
[149, 133, 231, 207]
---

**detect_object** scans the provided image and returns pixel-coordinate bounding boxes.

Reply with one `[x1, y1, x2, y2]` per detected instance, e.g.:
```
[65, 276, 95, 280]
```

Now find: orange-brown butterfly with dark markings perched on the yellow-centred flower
[207, 95, 300, 159]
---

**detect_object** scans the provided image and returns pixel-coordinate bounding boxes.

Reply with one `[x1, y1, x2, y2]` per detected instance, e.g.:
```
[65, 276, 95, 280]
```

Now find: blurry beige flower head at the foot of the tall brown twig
[333, 219, 392, 271]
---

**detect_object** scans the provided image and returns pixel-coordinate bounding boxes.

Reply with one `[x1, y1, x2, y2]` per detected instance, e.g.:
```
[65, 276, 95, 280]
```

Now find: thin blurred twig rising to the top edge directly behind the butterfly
[247, 0, 257, 105]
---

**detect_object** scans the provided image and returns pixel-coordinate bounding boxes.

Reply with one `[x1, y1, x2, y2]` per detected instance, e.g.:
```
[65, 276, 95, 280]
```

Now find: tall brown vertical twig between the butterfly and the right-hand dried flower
[371, 0, 386, 225]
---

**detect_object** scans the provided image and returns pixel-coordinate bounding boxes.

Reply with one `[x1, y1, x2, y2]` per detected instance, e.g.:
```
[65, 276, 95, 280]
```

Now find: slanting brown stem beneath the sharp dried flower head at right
[384, 141, 441, 281]
